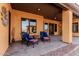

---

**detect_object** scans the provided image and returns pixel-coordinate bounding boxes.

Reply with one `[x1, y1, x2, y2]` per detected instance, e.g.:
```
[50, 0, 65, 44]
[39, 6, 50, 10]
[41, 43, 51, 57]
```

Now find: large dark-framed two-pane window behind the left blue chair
[22, 18, 36, 34]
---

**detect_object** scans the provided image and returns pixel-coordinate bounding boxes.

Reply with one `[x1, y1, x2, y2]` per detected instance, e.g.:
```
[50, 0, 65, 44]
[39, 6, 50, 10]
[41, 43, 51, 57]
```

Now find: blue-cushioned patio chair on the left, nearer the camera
[22, 32, 38, 48]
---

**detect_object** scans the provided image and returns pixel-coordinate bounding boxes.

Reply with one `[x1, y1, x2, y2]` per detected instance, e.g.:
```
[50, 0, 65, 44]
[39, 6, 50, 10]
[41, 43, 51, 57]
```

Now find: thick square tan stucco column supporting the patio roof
[62, 10, 72, 43]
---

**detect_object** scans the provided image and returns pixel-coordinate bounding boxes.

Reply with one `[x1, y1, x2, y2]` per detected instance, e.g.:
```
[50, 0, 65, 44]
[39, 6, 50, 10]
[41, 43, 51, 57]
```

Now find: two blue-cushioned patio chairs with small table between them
[22, 32, 50, 48]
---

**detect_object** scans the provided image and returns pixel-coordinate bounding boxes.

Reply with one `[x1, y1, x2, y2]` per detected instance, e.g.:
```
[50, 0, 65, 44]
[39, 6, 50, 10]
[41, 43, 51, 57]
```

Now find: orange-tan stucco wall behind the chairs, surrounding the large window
[11, 9, 60, 41]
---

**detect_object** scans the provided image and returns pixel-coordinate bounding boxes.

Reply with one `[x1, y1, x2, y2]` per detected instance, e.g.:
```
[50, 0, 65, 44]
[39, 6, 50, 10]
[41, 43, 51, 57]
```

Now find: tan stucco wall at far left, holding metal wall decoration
[0, 4, 11, 55]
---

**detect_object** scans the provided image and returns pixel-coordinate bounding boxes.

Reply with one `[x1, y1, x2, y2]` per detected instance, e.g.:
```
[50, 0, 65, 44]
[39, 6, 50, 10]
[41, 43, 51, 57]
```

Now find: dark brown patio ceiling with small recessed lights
[11, 3, 62, 21]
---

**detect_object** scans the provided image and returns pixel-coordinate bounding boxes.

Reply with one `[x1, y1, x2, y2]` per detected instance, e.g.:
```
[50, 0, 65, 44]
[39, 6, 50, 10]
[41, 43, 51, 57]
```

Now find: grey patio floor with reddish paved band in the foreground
[4, 36, 79, 56]
